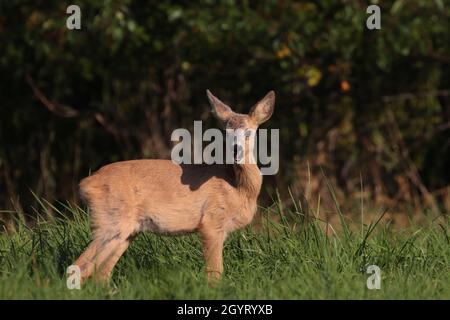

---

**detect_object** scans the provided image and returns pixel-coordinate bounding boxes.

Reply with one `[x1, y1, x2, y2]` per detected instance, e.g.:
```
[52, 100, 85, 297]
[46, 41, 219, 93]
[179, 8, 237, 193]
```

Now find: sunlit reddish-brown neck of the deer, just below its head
[234, 164, 262, 201]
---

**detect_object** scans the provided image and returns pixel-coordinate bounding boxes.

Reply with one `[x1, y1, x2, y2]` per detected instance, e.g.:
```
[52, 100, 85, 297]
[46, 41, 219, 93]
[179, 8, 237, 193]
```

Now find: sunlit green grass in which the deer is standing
[0, 200, 450, 299]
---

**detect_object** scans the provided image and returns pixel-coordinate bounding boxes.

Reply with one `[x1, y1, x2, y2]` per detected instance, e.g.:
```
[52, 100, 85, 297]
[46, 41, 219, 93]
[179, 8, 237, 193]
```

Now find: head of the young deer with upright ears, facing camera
[206, 90, 275, 163]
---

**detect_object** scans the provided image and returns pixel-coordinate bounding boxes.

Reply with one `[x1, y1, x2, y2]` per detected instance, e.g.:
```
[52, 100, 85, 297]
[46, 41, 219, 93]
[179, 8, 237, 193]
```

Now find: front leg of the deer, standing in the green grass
[201, 230, 225, 283]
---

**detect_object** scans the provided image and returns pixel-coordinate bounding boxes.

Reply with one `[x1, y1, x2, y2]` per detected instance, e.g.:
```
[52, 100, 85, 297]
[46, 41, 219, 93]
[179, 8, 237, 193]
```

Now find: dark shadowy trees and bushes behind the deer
[0, 0, 450, 229]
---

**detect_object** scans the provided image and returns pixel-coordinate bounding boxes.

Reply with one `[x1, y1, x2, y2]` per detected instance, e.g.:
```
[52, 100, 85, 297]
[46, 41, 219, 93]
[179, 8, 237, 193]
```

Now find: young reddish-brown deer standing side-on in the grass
[74, 90, 275, 283]
